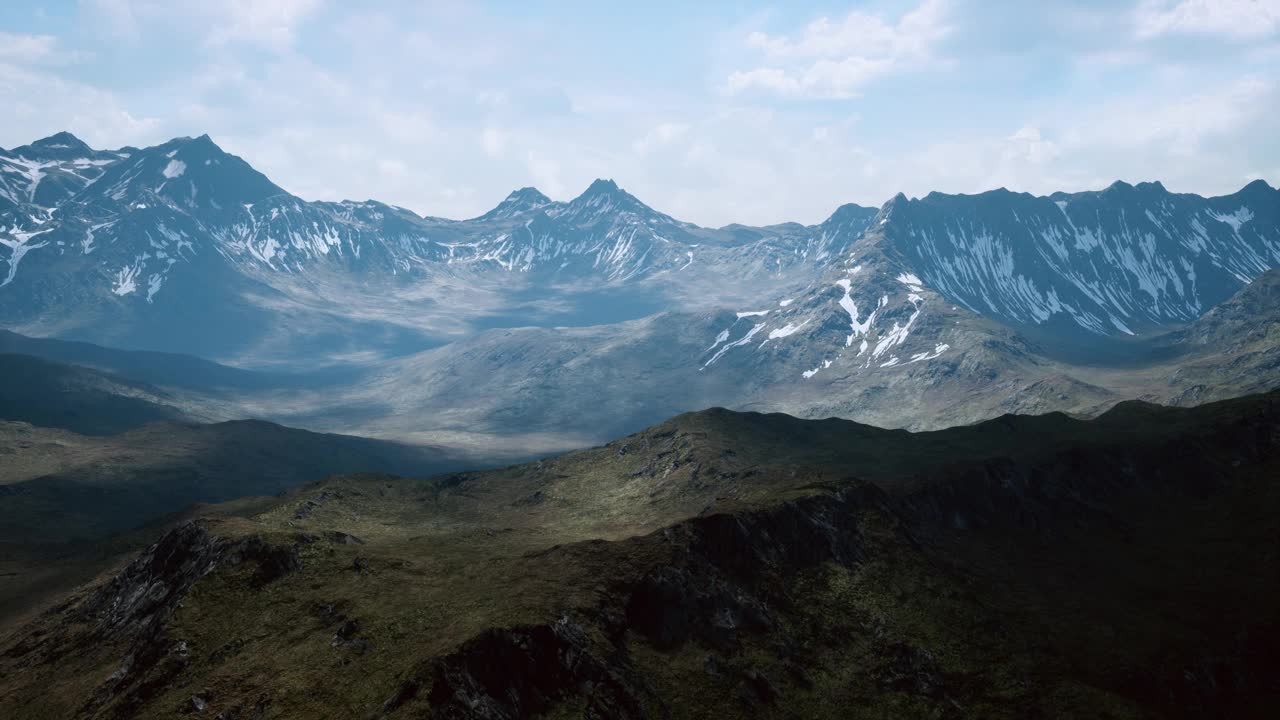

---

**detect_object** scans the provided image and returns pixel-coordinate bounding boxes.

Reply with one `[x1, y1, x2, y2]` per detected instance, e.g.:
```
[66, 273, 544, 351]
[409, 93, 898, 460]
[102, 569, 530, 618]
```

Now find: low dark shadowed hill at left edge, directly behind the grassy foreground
[0, 412, 458, 543]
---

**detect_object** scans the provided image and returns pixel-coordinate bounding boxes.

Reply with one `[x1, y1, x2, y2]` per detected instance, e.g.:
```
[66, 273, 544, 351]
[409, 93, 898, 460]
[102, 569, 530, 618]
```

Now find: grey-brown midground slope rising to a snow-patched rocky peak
[264, 266, 1280, 445]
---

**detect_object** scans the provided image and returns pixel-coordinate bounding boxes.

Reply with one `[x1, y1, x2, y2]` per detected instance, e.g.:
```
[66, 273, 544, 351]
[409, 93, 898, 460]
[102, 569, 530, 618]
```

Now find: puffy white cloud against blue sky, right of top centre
[726, 0, 951, 99]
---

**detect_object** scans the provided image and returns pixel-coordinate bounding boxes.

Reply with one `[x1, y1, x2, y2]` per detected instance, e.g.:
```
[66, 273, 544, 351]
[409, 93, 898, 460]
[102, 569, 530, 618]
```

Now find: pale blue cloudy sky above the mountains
[0, 0, 1280, 225]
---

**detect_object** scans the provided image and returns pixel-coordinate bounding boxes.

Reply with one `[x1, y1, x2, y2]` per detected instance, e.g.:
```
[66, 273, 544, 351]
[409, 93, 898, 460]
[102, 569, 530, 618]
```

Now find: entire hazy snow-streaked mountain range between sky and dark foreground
[0, 133, 1280, 452]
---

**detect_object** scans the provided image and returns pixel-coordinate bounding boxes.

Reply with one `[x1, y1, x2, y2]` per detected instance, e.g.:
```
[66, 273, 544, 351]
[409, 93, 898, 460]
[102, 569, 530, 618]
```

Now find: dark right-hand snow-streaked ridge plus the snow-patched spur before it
[705, 181, 1280, 386]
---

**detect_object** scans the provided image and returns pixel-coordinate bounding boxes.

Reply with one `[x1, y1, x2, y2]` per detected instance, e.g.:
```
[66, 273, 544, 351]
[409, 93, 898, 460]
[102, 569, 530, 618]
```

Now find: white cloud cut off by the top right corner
[1134, 0, 1280, 37]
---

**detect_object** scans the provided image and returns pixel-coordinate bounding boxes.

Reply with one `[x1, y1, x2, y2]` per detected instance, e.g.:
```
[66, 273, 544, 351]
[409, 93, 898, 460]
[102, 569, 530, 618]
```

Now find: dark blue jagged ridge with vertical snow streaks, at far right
[876, 181, 1280, 334]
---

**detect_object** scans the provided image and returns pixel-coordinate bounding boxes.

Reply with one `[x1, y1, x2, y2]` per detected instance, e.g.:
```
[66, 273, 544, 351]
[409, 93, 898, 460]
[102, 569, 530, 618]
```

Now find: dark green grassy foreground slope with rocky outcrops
[0, 393, 1280, 717]
